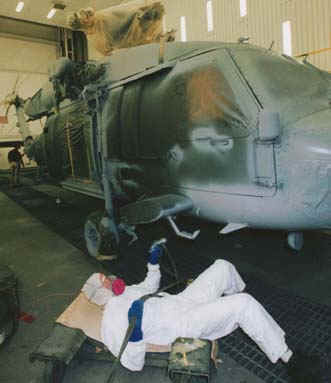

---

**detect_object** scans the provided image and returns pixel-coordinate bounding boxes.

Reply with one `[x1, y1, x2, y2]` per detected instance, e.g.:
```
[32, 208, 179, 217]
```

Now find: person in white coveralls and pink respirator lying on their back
[58, 245, 317, 383]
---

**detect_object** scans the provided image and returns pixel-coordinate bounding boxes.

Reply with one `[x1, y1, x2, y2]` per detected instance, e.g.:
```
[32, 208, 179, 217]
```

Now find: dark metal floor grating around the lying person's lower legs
[219, 275, 331, 383]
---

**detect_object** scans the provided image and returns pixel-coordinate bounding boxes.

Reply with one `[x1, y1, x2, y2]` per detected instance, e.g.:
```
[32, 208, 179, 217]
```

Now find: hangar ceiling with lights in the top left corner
[0, 0, 142, 26]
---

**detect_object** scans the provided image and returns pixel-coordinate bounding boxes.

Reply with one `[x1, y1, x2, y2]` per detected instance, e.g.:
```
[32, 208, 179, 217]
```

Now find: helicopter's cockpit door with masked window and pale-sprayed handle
[168, 49, 276, 196]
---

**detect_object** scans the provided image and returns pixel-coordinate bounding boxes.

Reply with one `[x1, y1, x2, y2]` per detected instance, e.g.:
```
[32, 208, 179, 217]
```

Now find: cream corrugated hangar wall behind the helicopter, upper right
[89, 0, 331, 71]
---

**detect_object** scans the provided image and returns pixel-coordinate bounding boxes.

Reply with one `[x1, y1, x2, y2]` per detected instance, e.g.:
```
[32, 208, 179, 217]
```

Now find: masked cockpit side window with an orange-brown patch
[170, 49, 258, 142]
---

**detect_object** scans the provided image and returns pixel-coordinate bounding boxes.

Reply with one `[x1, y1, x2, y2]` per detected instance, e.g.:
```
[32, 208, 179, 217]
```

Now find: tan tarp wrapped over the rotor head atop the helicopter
[68, 2, 175, 56]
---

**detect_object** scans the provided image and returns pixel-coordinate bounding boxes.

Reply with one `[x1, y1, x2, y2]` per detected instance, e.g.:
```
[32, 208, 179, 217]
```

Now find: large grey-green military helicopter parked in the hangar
[4, 42, 331, 257]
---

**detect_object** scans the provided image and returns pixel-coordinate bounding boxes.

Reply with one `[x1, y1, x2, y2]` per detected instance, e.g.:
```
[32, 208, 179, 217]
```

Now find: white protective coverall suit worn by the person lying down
[101, 259, 288, 371]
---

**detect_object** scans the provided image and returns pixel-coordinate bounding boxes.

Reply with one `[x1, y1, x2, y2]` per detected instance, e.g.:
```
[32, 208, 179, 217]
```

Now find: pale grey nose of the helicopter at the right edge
[289, 109, 331, 228]
